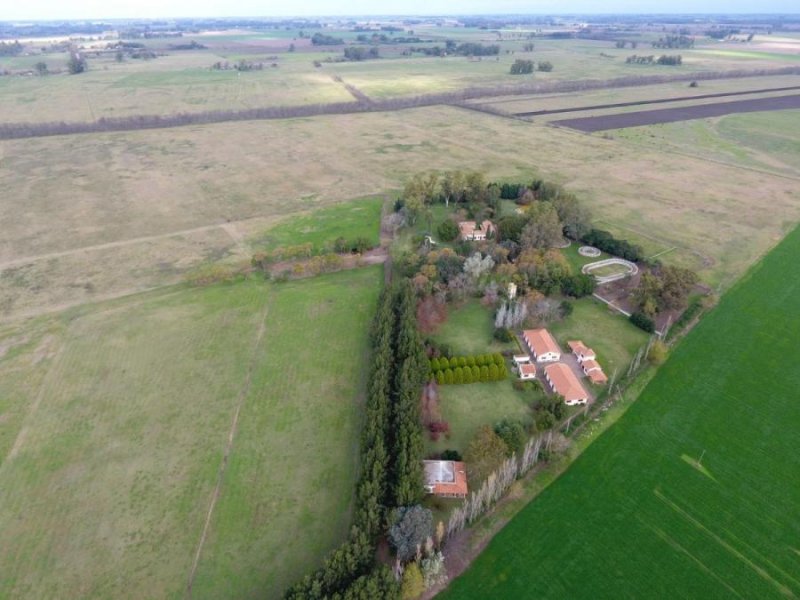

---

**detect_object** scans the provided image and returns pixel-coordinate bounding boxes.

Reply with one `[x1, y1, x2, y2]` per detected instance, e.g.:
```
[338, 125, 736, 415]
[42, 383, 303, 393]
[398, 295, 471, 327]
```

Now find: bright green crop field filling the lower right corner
[442, 230, 800, 599]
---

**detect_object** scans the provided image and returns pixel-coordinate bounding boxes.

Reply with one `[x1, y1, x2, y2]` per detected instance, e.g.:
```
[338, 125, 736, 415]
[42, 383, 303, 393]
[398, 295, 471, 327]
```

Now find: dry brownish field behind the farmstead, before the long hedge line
[0, 99, 800, 318]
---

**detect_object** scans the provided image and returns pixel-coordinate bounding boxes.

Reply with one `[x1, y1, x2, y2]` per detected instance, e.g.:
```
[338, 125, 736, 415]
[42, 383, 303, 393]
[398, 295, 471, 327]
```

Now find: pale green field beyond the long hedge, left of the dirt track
[0, 49, 352, 122]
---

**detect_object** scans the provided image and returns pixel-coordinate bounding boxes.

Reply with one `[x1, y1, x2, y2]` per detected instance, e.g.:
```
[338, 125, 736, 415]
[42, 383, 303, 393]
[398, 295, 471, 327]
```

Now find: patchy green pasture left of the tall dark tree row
[0, 267, 382, 598]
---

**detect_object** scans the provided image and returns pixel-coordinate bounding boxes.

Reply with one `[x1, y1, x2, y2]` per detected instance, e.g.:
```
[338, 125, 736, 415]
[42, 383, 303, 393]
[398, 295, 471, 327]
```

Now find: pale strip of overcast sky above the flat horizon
[0, 0, 800, 20]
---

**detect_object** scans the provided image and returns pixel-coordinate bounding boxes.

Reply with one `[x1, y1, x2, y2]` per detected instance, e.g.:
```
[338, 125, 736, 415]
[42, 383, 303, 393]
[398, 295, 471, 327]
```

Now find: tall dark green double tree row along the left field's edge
[285, 281, 428, 600]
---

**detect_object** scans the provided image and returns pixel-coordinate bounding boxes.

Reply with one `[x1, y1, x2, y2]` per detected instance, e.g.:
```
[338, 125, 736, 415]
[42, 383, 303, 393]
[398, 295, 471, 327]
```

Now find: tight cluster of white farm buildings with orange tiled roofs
[514, 329, 608, 406]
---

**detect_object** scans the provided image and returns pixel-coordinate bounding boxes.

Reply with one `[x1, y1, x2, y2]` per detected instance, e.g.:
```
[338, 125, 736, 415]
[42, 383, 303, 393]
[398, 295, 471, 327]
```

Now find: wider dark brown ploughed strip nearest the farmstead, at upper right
[551, 94, 800, 133]
